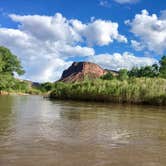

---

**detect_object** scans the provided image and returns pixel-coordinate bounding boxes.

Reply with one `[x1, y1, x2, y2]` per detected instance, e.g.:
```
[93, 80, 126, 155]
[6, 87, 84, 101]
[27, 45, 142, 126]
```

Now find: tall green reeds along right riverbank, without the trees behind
[50, 78, 166, 105]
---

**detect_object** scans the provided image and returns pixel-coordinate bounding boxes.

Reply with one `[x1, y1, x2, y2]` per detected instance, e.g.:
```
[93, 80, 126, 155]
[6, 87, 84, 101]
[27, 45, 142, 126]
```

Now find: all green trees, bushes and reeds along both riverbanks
[0, 47, 166, 105]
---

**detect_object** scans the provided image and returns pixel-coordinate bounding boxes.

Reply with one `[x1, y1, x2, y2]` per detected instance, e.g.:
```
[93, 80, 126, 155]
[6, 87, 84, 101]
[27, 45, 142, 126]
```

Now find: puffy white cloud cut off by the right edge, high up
[126, 10, 166, 54]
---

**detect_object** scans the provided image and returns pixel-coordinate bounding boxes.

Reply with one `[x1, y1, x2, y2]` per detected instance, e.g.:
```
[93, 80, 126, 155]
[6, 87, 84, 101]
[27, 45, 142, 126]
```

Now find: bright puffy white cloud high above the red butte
[70, 19, 127, 46]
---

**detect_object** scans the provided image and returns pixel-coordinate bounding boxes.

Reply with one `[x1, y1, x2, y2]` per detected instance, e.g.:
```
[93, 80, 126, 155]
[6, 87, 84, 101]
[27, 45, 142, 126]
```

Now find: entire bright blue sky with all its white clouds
[0, 0, 166, 82]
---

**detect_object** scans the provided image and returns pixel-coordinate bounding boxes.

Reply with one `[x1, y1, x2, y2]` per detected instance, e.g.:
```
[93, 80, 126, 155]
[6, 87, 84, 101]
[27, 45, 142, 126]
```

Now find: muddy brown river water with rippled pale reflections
[0, 96, 166, 166]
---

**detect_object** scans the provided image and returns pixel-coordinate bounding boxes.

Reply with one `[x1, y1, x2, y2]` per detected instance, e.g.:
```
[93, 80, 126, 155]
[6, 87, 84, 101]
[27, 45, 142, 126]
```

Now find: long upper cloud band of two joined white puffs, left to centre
[10, 13, 127, 46]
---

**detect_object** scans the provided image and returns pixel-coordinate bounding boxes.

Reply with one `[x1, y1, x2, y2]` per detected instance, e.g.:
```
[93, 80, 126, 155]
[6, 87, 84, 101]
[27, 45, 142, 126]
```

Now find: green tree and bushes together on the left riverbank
[0, 46, 39, 94]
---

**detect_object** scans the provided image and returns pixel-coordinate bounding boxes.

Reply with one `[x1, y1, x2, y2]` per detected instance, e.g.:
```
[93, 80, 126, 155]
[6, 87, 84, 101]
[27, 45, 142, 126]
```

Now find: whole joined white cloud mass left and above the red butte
[0, 13, 127, 81]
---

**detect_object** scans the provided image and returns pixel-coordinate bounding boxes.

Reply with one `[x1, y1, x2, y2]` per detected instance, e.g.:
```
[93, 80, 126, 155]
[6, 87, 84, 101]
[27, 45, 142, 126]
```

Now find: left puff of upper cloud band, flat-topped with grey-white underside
[10, 13, 80, 42]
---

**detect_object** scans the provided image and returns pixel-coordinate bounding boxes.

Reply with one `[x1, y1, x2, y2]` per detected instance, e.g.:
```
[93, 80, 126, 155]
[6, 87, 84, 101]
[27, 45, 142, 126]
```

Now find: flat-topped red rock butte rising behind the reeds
[59, 62, 116, 82]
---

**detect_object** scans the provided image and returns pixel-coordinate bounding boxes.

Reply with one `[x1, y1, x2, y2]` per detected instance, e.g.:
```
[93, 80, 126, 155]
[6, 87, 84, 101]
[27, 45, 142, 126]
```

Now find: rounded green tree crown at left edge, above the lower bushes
[0, 46, 24, 75]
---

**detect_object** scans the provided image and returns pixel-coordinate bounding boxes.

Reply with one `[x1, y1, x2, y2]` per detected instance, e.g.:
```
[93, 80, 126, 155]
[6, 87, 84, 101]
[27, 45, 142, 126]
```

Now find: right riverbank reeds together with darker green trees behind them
[50, 56, 166, 105]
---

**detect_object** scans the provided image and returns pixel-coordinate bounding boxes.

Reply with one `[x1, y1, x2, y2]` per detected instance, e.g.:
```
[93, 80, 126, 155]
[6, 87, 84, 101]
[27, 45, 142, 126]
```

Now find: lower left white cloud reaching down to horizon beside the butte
[0, 28, 95, 81]
